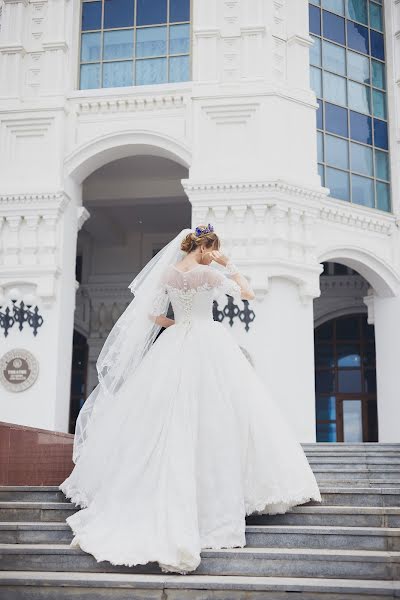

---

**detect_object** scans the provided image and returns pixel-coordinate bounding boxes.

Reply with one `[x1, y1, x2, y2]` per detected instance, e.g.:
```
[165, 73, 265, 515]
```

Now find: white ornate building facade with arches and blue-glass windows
[0, 0, 400, 442]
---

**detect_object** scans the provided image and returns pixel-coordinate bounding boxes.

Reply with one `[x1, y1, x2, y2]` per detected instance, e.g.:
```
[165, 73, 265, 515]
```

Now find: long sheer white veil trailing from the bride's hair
[72, 228, 193, 463]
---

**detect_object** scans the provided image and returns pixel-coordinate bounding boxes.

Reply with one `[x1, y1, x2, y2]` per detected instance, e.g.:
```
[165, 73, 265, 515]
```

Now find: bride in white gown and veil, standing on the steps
[59, 224, 321, 573]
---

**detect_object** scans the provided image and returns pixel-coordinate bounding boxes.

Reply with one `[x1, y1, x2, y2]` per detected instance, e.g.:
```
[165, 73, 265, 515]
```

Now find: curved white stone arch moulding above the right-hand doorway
[318, 246, 400, 297]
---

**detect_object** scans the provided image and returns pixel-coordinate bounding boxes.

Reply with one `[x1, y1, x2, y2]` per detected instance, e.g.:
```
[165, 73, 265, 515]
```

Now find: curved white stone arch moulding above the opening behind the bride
[65, 130, 191, 184]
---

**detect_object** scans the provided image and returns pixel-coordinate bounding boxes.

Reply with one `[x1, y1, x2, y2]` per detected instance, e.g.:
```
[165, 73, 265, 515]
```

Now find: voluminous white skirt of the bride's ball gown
[59, 267, 321, 573]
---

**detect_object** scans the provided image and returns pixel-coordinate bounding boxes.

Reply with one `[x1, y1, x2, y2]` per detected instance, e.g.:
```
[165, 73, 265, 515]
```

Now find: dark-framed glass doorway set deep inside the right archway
[315, 314, 378, 442]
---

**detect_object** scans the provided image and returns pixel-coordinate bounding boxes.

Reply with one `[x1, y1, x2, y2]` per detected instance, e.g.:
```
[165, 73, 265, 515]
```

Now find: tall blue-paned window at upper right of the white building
[309, 0, 391, 211]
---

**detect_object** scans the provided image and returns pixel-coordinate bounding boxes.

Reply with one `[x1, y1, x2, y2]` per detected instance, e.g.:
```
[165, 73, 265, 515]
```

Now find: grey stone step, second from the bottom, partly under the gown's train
[0, 544, 400, 580]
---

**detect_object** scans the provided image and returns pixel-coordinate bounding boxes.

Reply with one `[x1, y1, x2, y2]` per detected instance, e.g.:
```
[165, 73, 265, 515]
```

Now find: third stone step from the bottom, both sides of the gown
[0, 522, 400, 551]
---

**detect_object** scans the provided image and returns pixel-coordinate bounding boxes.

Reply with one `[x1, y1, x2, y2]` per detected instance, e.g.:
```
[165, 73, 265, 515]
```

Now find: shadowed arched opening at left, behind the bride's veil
[70, 154, 191, 433]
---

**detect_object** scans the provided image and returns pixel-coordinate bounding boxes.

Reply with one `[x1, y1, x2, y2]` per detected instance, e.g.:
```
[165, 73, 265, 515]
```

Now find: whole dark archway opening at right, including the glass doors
[314, 261, 383, 442]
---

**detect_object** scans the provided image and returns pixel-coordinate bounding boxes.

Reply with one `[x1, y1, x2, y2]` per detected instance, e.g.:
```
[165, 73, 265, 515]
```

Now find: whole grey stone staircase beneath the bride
[0, 443, 400, 600]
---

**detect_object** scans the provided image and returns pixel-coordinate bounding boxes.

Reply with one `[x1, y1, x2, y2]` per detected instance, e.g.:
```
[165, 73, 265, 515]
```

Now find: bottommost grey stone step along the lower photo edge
[0, 571, 400, 600]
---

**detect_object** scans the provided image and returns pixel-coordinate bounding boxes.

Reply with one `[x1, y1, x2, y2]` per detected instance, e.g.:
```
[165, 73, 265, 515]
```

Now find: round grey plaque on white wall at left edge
[0, 348, 39, 392]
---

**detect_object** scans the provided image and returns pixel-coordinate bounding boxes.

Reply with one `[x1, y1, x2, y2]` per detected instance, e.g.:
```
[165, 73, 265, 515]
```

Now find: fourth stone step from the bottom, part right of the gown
[246, 505, 400, 527]
